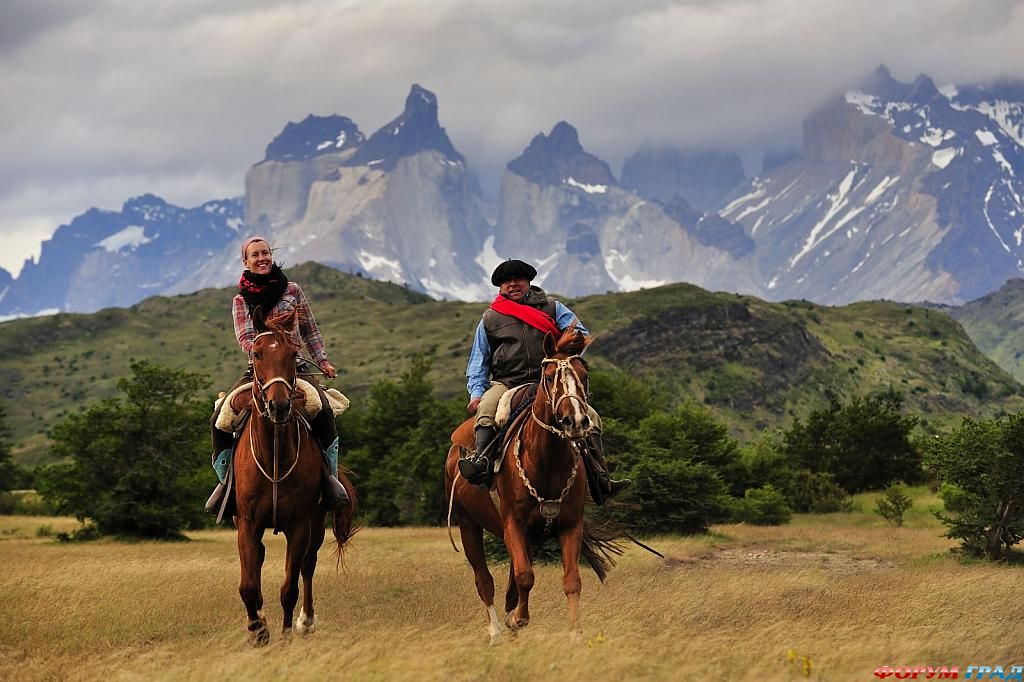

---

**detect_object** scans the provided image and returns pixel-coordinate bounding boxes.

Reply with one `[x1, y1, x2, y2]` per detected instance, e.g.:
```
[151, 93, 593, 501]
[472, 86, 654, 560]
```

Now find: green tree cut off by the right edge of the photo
[925, 413, 1024, 559]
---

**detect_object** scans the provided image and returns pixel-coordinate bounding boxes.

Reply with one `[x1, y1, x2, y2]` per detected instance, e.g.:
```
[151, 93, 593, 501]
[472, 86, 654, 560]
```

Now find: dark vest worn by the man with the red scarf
[483, 297, 555, 388]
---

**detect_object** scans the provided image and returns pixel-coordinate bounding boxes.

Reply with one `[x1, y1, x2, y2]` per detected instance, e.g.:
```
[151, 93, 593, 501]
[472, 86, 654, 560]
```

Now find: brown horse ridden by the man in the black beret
[444, 328, 622, 644]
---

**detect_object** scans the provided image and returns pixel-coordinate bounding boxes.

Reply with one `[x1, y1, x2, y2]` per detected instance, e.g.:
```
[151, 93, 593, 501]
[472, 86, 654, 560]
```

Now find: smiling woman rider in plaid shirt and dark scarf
[206, 237, 348, 514]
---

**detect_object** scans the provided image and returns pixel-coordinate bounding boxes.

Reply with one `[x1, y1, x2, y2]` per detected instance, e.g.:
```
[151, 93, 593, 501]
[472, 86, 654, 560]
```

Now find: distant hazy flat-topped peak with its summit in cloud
[623, 145, 746, 210]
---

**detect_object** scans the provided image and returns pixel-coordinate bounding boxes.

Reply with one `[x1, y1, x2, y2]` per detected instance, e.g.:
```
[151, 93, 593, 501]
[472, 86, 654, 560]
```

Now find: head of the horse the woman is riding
[252, 311, 299, 424]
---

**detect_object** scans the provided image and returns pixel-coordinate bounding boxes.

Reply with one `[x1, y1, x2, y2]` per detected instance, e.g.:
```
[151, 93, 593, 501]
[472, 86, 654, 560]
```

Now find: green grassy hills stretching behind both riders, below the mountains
[0, 263, 1024, 465]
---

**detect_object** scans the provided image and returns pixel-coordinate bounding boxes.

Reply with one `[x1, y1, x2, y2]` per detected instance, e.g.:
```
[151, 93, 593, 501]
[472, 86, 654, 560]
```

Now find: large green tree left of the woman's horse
[38, 360, 210, 538]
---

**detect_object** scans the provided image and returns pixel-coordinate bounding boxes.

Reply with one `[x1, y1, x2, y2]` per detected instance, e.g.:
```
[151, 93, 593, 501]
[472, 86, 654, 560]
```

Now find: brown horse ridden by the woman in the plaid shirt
[234, 313, 355, 646]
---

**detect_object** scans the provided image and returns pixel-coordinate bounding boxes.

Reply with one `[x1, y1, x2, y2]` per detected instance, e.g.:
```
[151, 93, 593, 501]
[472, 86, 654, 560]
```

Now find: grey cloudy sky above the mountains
[0, 0, 1024, 273]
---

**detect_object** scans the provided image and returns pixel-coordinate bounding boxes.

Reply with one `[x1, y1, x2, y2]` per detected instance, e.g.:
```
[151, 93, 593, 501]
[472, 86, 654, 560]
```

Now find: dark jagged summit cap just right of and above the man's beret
[508, 121, 617, 187]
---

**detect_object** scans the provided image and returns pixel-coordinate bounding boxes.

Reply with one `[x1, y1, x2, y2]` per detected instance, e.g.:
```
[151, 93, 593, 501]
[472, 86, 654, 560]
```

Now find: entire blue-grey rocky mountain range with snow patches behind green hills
[0, 67, 1024, 315]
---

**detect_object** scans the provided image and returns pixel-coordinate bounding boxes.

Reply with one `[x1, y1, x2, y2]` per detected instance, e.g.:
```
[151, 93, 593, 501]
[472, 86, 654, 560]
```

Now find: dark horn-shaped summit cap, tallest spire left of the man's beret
[345, 85, 466, 170]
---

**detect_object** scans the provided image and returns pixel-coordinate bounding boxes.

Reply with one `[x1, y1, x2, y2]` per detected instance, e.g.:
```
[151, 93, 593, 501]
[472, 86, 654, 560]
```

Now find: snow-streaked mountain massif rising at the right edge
[719, 68, 1024, 303]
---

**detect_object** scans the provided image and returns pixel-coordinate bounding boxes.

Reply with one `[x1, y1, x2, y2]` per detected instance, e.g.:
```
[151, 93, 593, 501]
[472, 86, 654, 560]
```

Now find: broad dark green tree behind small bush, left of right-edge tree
[783, 392, 922, 493]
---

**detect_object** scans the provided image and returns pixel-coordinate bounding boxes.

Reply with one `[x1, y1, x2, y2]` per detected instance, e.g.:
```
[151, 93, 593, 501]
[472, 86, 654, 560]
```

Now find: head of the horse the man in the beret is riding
[537, 321, 593, 439]
